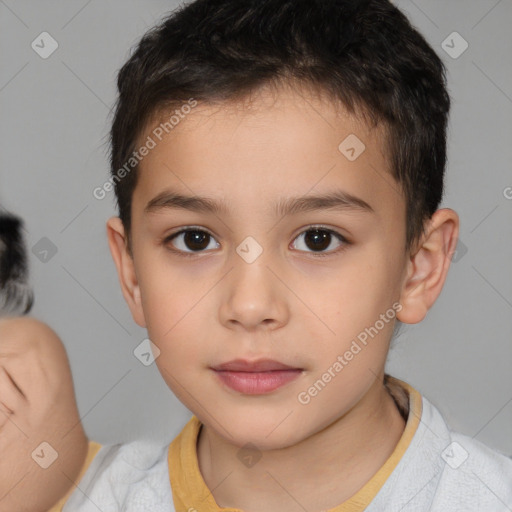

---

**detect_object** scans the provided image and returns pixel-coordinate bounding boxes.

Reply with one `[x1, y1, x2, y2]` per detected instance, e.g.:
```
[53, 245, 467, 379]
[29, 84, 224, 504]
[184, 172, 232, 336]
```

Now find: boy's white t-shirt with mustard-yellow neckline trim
[62, 379, 512, 512]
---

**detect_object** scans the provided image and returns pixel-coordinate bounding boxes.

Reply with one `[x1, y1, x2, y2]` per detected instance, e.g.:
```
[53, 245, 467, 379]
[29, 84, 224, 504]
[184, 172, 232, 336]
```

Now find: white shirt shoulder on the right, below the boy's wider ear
[367, 381, 512, 512]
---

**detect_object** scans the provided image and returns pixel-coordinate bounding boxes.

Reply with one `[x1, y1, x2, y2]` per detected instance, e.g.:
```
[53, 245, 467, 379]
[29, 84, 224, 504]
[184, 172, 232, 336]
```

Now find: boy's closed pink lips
[212, 359, 304, 395]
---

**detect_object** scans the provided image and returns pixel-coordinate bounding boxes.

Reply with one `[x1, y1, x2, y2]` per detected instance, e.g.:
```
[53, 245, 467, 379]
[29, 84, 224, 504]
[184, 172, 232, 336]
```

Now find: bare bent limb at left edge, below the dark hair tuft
[0, 317, 88, 512]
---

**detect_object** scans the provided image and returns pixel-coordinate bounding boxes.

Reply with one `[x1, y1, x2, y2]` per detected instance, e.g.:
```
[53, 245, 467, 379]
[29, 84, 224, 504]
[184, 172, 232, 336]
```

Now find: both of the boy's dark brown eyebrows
[144, 190, 375, 216]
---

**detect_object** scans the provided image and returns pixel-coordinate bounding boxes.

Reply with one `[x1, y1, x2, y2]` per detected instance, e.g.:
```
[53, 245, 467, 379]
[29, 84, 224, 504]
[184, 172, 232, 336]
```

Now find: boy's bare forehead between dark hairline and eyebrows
[134, 84, 401, 222]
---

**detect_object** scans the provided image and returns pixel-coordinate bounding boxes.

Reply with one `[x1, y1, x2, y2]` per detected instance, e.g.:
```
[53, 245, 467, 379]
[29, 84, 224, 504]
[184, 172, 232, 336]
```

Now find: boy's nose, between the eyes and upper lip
[219, 253, 289, 331]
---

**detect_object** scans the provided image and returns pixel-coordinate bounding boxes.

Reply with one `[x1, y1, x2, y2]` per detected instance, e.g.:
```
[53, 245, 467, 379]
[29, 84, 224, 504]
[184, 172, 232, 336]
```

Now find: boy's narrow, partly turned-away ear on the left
[107, 217, 146, 327]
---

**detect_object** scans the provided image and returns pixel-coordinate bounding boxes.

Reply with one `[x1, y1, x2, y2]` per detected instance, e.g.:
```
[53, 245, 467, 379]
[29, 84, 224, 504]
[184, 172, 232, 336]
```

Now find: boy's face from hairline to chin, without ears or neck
[112, 86, 408, 448]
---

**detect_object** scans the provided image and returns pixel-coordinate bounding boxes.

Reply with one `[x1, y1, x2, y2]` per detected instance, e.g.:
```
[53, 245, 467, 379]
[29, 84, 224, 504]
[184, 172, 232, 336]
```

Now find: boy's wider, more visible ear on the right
[397, 208, 459, 324]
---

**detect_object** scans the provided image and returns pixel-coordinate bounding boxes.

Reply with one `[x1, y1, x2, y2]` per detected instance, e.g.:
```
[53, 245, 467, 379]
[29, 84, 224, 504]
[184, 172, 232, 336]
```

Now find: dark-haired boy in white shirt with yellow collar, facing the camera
[9, 0, 512, 512]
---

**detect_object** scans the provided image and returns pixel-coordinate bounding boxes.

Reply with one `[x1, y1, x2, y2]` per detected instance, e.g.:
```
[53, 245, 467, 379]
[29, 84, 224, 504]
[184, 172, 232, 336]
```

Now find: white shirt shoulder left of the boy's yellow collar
[62, 439, 173, 512]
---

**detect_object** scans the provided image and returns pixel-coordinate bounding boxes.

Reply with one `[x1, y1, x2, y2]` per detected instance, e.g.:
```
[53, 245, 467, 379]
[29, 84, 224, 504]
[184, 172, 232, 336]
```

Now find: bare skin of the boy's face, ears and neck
[107, 87, 459, 512]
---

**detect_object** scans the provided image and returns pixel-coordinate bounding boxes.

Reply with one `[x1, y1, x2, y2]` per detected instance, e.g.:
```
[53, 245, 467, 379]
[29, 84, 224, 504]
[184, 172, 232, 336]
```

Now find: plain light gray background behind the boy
[0, 0, 512, 454]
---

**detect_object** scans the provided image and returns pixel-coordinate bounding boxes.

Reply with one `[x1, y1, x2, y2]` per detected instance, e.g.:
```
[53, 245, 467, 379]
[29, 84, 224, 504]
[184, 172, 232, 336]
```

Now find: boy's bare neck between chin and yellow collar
[197, 378, 405, 512]
